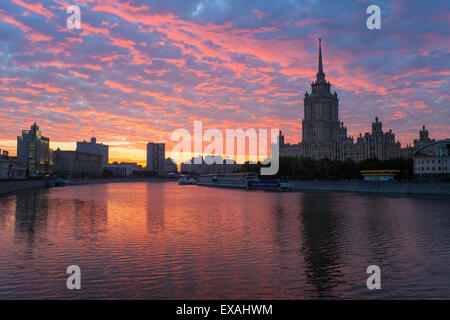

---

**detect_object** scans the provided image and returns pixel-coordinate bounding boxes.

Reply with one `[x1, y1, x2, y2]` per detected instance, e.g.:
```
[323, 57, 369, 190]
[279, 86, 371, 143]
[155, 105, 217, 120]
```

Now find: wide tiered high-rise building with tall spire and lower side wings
[279, 39, 430, 162]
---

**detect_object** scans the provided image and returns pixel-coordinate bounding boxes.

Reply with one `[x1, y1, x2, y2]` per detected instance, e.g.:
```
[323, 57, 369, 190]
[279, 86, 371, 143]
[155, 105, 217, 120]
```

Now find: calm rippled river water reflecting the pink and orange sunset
[0, 182, 450, 299]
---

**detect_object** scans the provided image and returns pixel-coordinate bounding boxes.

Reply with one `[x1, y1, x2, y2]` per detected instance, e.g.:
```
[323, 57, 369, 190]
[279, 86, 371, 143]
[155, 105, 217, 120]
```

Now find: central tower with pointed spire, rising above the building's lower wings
[302, 39, 347, 145]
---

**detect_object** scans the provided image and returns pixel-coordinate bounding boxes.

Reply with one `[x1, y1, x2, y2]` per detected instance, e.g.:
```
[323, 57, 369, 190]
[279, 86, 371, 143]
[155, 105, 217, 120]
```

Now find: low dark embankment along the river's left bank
[0, 178, 175, 195]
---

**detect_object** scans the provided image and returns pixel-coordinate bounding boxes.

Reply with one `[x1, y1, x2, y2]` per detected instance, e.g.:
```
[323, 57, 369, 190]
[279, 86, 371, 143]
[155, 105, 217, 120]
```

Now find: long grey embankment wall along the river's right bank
[291, 181, 450, 196]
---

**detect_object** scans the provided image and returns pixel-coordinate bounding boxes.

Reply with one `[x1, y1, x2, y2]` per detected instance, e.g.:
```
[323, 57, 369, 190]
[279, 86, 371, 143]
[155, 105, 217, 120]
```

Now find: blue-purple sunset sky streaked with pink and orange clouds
[0, 0, 450, 164]
